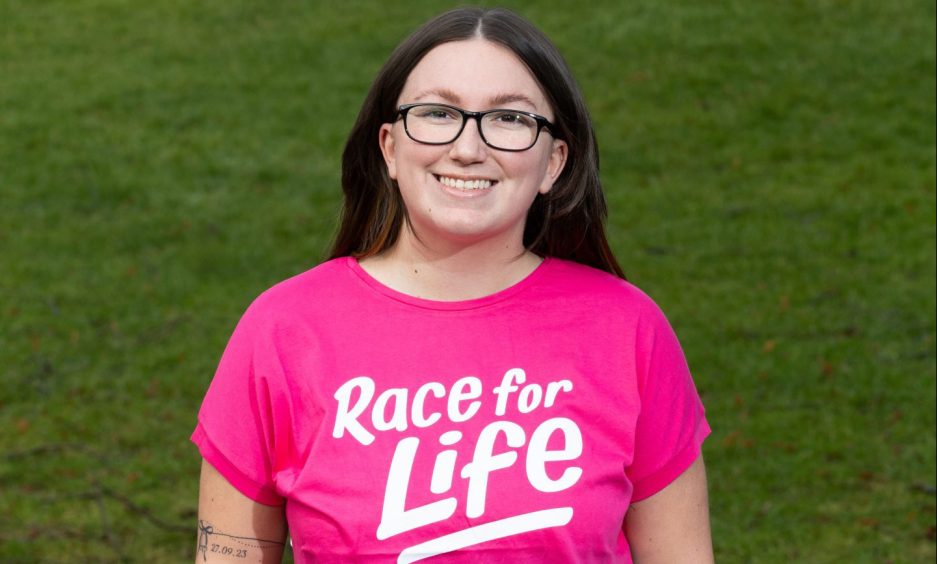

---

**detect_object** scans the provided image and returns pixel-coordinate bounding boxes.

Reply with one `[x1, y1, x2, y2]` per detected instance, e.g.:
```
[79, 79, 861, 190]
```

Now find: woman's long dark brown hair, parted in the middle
[330, 4, 625, 278]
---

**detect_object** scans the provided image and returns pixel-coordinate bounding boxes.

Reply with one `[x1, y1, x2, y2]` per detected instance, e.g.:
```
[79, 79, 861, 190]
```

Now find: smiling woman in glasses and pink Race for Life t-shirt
[193, 9, 712, 563]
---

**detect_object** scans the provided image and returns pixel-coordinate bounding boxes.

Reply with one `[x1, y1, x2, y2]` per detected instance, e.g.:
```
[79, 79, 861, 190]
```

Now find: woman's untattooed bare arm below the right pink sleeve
[625, 455, 714, 564]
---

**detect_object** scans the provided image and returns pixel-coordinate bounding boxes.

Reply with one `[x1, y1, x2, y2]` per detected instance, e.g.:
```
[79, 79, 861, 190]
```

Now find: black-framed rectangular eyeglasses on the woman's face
[397, 104, 555, 152]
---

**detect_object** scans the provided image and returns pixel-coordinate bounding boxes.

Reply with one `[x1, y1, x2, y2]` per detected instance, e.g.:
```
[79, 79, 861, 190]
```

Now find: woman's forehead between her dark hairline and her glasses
[398, 38, 550, 114]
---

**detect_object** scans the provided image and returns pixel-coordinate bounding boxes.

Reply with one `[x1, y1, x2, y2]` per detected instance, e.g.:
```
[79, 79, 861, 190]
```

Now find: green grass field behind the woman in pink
[0, 0, 937, 563]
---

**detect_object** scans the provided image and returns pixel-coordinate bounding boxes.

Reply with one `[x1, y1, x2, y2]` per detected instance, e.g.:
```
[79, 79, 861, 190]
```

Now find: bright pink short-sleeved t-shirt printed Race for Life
[192, 258, 709, 563]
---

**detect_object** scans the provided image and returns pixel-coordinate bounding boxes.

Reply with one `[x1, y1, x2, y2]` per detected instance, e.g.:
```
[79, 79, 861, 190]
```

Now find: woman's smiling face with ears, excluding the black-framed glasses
[380, 39, 566, 250]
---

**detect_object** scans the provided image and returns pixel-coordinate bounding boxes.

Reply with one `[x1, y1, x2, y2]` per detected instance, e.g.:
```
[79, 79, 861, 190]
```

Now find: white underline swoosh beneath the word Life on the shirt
[397, 507, 573, 564]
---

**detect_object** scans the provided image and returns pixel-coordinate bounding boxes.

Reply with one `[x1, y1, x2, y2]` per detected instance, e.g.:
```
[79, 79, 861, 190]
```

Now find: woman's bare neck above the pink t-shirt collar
[361, 228, 542, 301]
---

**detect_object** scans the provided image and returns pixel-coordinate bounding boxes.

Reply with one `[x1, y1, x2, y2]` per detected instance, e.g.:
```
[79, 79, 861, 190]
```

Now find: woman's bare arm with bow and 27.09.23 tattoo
[195, 459, 287, 564]
